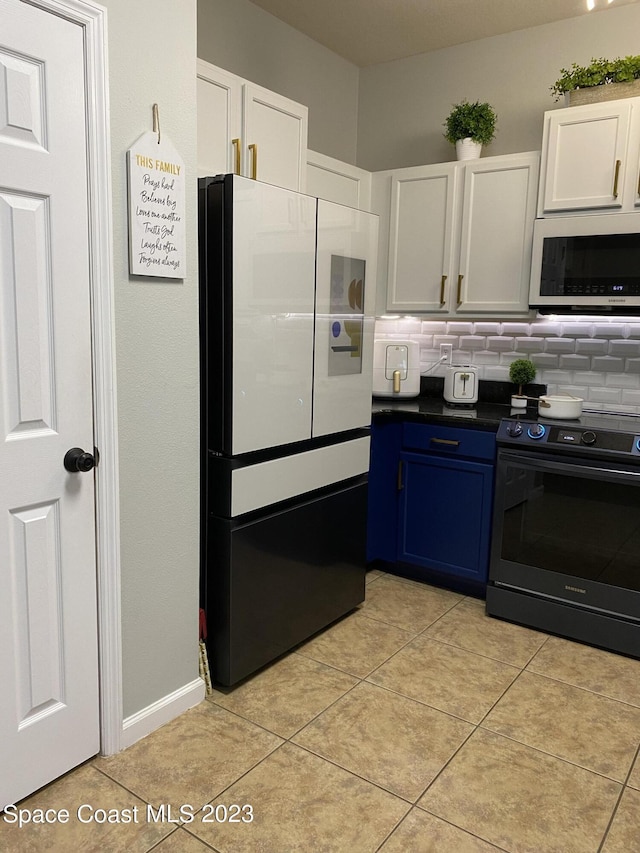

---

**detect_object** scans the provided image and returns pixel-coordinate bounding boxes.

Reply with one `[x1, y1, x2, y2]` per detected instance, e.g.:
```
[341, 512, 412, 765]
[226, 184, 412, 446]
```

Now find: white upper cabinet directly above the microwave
[538, 98, 640, 216]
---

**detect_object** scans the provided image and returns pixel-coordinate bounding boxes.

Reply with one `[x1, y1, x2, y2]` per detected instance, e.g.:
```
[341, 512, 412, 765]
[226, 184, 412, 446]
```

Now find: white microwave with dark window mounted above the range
[529, 211, 640, 315]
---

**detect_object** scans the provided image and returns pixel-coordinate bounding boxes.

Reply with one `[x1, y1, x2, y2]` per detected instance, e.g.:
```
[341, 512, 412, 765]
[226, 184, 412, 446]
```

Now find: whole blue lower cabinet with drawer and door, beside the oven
[367, 421, 496, 595]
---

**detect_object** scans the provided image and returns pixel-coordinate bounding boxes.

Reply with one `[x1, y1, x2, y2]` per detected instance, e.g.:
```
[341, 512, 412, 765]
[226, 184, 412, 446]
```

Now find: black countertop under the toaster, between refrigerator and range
[372, 377, 546, 432]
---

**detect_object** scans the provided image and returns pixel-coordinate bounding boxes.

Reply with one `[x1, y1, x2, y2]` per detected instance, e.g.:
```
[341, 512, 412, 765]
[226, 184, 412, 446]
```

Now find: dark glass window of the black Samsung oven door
[500, 461, 640, 590]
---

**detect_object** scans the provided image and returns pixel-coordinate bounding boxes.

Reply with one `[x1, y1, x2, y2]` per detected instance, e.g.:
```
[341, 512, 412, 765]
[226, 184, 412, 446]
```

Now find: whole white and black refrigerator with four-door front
[199, 175, 378, 685]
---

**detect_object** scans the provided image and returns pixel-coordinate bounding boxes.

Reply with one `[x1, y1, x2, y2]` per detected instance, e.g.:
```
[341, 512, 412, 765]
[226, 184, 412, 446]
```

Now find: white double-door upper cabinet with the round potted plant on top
[372, 152, 539, 317]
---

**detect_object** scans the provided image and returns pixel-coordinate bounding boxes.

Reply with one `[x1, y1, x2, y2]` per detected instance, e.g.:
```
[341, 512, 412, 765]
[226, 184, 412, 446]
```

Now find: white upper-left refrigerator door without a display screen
[232, 177, 316, 455]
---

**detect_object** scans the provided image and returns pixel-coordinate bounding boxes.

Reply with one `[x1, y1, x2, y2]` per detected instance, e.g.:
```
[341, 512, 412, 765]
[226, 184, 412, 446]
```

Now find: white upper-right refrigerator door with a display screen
[313, 199, 378, 436]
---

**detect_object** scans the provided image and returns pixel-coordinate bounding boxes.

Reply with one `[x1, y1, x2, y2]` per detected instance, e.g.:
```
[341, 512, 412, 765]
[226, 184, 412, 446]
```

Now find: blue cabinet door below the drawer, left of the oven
[397, 452, 494, 583]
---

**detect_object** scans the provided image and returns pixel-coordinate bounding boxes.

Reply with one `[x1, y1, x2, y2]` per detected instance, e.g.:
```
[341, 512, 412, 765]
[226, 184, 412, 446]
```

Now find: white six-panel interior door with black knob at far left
[0, 0, 99, 808]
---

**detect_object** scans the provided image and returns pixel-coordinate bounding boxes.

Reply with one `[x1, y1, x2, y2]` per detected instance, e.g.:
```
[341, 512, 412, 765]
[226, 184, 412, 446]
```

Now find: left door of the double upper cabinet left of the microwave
[387, 163, 459, 313]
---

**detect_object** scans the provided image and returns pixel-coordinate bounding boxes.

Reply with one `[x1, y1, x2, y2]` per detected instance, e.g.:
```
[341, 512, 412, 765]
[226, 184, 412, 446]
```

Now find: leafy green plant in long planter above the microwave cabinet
[550, 56, 640, 104]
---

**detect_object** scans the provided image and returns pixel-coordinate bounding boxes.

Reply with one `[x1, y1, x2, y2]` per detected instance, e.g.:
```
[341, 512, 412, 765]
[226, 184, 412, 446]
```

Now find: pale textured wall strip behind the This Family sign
[102, 0, 199, 717]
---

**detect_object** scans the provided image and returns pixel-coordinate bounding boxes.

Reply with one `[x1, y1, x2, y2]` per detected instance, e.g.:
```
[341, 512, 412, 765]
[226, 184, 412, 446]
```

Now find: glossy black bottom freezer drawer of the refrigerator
[204, 475, 367, 686]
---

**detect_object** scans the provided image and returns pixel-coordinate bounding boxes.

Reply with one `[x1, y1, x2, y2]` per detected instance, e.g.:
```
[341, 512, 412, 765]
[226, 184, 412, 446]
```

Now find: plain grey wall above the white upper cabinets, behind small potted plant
[357, 4, 640, 171]
